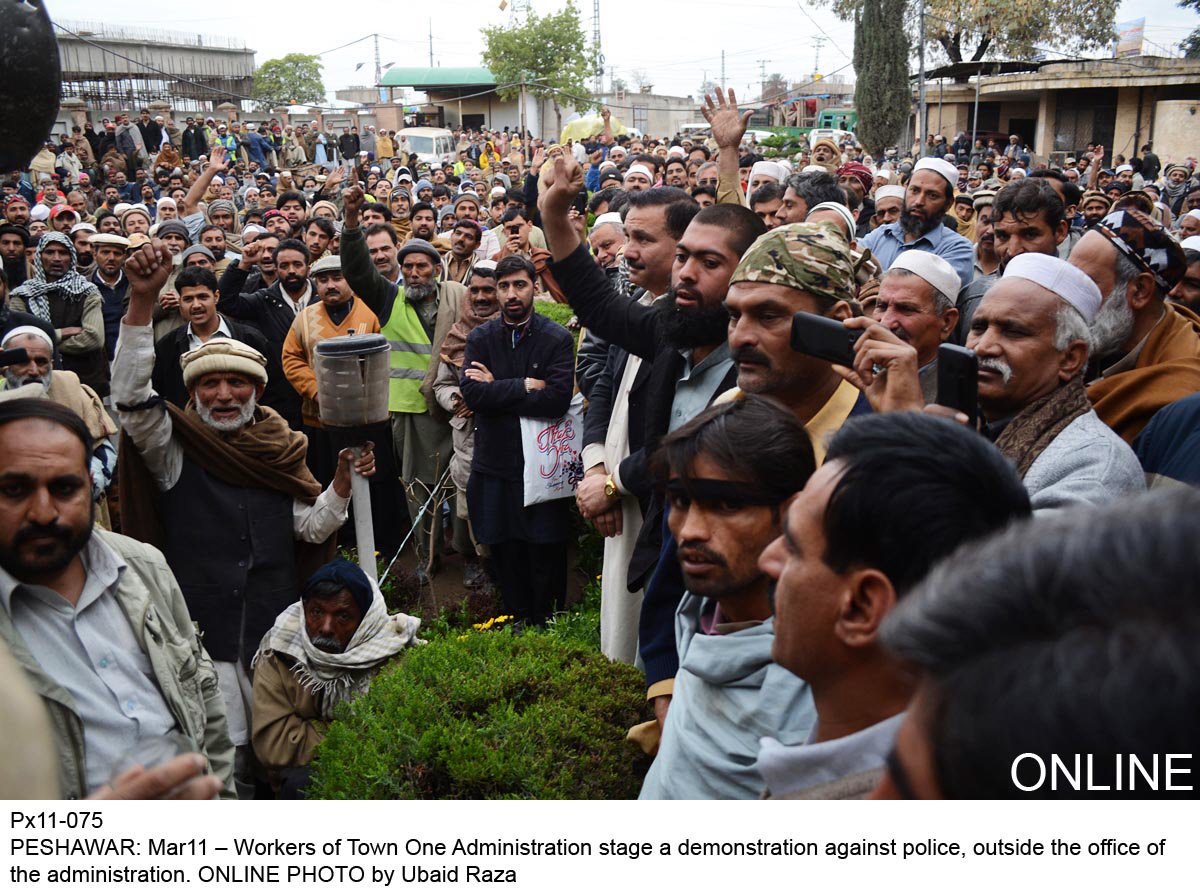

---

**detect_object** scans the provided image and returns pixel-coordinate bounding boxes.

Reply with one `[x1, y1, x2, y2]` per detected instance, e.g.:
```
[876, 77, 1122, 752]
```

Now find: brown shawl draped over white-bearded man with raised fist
[118, 401, 337, 571]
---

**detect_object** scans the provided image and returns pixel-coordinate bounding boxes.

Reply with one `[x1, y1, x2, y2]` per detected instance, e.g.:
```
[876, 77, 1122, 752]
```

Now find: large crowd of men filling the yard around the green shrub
[0, 91, 1200, 798]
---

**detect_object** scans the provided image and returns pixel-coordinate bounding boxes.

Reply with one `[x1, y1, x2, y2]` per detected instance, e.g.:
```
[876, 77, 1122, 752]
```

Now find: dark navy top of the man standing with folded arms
[462, 313, 575, 481]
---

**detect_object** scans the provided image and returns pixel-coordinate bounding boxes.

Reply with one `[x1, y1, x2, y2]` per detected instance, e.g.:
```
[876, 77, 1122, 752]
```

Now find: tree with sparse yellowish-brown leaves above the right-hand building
[821, 0, 1117, 62]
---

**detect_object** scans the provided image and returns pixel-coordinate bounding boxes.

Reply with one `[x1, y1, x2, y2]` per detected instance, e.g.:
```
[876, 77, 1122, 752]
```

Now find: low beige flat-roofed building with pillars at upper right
[913, 56, 1200, 163]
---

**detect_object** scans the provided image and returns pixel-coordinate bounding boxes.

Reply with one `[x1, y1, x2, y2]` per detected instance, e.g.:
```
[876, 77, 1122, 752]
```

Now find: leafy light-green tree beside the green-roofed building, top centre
[482, 0, 596, 139]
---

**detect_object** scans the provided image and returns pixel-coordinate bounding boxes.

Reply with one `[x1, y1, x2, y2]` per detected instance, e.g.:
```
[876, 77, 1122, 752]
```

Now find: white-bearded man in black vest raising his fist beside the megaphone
[113, 240, 374, 797]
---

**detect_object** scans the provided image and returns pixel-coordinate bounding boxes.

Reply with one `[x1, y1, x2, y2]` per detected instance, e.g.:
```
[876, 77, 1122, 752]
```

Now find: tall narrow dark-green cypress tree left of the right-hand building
[854, 0, 912, 158]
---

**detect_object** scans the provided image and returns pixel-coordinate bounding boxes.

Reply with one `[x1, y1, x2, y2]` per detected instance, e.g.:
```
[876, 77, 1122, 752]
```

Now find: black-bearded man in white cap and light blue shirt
[859, 158, 974, 286]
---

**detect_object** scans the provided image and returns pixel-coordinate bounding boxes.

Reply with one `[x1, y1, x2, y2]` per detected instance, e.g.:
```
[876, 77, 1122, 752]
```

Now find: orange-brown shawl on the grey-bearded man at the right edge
[1087, 302, 1200, 444]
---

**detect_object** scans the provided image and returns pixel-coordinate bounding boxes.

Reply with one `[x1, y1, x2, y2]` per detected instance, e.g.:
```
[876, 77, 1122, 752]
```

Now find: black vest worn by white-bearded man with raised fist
[162, 457, 300, 671]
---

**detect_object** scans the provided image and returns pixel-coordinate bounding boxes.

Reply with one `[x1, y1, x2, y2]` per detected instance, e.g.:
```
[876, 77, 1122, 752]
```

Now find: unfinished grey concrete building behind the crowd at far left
[55, 22, 254, 121]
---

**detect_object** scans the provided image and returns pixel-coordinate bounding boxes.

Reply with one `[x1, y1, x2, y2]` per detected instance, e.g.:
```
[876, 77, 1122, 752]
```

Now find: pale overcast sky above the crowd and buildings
[47, 0, 1200, 98]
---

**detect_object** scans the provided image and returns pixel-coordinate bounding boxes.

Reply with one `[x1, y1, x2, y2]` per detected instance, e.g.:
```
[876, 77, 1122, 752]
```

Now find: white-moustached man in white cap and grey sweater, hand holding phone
[844, 253, 1145, 511]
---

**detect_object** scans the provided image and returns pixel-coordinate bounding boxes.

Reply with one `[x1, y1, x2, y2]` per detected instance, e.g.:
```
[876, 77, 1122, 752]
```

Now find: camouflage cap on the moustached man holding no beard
[730, 221, 854, 302]
